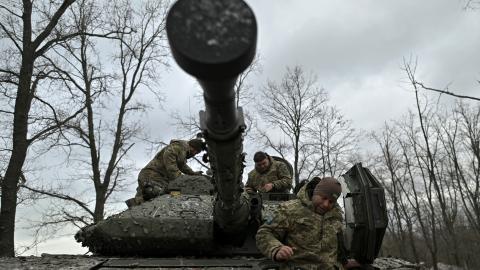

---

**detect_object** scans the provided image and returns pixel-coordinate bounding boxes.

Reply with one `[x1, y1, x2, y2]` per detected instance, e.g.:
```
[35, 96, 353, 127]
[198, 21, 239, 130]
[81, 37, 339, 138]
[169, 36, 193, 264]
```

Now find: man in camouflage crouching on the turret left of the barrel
[131, 139, 205, 205]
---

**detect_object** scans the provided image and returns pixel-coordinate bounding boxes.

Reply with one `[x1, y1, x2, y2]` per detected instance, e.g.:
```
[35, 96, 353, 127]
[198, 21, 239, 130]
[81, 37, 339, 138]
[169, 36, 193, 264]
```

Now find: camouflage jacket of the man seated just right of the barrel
[245, 157, 292, 192]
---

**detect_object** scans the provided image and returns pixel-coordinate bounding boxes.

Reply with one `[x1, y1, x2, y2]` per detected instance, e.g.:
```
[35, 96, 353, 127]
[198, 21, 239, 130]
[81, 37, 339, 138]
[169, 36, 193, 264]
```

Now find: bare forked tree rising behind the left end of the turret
[23, 1, 172, 230]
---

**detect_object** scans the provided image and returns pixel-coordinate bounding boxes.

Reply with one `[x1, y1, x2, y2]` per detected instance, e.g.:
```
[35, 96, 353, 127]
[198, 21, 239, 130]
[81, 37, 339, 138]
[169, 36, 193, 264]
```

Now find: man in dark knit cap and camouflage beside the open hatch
[256, 177, 359, 270]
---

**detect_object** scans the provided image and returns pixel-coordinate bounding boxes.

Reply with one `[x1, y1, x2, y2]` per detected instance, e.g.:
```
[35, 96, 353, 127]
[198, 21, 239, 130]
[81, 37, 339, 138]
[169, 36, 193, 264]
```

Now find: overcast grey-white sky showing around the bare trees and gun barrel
[10, 0, 480, 255]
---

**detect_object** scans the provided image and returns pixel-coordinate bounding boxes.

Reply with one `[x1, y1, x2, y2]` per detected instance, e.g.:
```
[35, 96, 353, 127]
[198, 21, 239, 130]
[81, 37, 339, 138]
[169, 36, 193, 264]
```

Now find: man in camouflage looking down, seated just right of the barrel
[245, 152, 292, 193]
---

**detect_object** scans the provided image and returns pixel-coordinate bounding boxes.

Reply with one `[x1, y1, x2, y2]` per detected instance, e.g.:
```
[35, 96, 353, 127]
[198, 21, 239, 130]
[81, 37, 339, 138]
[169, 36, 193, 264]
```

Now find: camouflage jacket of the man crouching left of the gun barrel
[142, 140, 194, 180]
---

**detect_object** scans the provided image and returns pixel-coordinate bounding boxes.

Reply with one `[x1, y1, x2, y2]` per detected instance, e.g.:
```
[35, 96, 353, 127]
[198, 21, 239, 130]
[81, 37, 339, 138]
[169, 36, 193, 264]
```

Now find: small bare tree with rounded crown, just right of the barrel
[257, 66, 327, 185]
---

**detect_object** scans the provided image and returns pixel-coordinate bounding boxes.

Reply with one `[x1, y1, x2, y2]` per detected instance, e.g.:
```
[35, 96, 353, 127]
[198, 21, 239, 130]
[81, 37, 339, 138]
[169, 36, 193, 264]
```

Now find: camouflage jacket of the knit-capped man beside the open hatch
[256, 186, 343, 270]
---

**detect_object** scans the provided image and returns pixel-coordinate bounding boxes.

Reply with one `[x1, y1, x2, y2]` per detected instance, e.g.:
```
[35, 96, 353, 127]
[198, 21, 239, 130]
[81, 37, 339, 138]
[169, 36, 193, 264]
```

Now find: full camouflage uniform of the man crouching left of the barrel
[135, 140, 195, 204]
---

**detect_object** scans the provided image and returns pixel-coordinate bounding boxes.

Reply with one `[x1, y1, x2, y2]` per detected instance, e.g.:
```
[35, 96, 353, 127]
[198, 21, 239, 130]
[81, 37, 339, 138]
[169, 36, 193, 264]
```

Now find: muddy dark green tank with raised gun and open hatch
[75, 0, 387, 269]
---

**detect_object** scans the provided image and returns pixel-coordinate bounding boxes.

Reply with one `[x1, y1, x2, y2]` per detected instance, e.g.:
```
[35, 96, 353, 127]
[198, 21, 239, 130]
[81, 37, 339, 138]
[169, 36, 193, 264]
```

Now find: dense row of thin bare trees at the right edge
[372, 60, 480, 269]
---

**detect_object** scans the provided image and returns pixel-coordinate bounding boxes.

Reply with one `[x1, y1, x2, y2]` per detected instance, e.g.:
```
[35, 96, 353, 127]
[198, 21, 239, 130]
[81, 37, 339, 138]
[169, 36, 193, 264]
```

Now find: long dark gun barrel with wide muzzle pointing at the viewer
[167, 0, 257, 239]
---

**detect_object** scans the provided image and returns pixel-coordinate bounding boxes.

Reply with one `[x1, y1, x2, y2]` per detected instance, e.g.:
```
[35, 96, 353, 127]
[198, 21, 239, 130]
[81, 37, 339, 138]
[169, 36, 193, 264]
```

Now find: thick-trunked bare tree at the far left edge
[0, 0, 79, 256]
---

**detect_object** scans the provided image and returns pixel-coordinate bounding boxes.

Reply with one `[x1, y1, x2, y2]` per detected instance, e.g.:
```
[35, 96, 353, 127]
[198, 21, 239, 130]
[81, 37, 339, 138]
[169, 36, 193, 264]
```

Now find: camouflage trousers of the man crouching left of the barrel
[135, 169, 168, 205]
